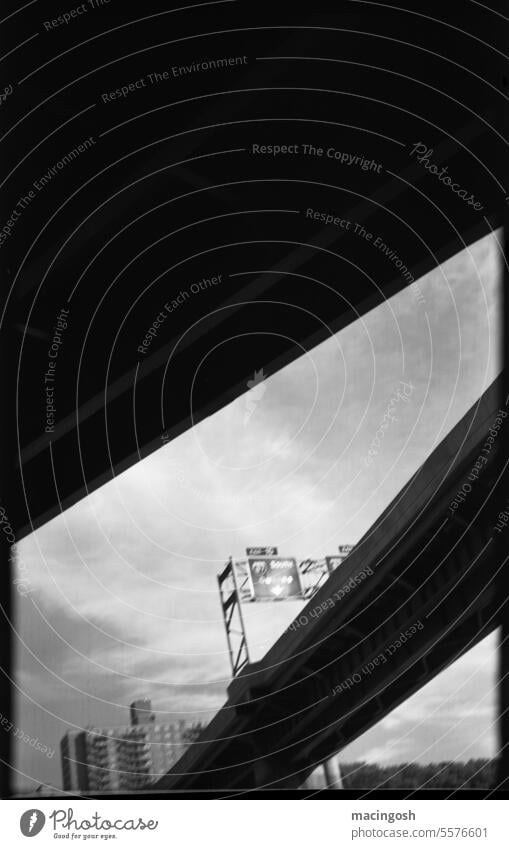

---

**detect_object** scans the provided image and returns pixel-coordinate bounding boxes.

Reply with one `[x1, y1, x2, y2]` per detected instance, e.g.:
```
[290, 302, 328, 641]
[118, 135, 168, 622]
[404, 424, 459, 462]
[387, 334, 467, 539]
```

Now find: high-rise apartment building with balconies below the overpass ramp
[60, 699, 200, 791]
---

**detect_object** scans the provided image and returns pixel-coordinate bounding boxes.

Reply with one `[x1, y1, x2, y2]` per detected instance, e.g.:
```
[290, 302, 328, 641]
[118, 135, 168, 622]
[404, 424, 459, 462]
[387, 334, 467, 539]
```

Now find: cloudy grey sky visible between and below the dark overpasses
[10, 230, 500, 788]
